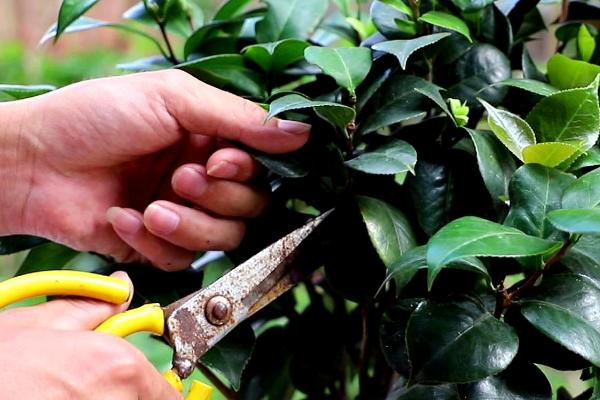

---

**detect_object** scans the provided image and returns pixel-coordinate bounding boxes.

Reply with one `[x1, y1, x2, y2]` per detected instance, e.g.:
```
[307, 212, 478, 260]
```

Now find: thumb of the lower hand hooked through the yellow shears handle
[0, 271, 133, 331]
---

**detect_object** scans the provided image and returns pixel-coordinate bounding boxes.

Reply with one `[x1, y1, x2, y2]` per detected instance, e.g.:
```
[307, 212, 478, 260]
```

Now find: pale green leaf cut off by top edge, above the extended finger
[256, 0, 328, 43]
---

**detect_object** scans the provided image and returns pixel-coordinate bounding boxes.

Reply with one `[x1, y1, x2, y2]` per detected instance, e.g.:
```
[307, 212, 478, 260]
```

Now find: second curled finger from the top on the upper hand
[172, 161, 268, 218]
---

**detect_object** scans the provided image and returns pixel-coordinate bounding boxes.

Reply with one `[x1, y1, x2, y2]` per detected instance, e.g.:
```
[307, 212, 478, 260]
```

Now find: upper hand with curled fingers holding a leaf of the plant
[0, 70, 309, 269]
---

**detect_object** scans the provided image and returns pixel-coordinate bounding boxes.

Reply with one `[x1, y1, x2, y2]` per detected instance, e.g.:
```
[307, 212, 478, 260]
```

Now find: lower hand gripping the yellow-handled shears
[0, 274, 181, 400]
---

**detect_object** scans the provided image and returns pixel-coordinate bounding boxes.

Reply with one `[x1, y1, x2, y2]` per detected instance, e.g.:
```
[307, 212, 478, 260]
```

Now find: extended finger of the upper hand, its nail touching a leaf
[160, 70, 310, 153]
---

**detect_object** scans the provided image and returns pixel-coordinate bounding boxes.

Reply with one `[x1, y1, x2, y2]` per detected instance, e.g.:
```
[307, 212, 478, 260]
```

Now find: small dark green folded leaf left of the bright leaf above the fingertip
[242, 39, 308, 72]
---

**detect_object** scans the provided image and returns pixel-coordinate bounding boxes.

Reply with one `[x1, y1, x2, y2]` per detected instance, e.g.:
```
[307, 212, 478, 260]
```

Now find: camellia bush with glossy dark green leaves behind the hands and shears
[5, 0, 600, 400]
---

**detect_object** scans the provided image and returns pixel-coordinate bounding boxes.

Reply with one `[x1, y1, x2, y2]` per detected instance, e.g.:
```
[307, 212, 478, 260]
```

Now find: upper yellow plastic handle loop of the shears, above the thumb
[0, 271, 129, 308]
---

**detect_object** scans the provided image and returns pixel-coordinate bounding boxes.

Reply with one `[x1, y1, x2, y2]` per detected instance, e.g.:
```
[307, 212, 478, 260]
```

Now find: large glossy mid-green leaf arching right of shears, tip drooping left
[427, 217, 560, 287]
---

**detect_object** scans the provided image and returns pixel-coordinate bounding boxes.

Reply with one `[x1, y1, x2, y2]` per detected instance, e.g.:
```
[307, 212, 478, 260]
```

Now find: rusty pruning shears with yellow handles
[0, 211, 331, 400]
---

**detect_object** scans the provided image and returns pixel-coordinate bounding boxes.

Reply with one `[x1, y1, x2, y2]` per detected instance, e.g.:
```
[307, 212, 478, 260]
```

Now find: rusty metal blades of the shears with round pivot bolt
[165, 211, 331, 378]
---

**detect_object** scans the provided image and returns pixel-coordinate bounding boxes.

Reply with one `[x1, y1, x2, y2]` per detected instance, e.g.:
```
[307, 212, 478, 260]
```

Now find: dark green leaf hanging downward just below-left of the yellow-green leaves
[467, 129, 517, 206]
